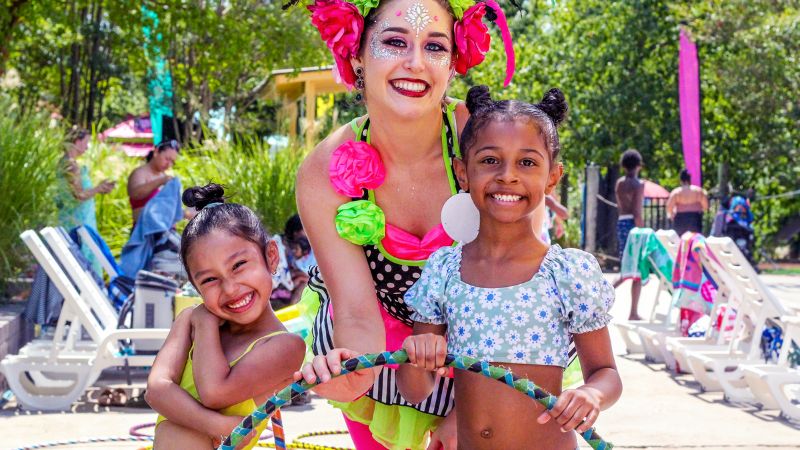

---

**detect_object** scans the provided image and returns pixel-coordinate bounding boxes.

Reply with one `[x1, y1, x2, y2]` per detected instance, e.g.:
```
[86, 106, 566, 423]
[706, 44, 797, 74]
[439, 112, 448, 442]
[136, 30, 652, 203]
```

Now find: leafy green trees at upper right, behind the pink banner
[451, 0, 800, 253]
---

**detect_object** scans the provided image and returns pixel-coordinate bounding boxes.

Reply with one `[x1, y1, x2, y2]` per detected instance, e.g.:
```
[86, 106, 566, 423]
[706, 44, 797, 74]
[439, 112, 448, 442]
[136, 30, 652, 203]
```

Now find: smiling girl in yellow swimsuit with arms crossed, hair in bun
[146, 184, 305, 449]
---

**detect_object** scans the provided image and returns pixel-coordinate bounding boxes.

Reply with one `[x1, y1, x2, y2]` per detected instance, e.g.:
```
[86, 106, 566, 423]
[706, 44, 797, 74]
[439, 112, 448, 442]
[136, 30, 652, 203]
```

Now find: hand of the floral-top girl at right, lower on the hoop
[536, 386, 600, 433]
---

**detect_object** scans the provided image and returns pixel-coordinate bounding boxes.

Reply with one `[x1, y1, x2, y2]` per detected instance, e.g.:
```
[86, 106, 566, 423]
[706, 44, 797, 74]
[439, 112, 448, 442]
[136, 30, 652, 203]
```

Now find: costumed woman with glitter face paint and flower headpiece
[297, 0, 513, 450]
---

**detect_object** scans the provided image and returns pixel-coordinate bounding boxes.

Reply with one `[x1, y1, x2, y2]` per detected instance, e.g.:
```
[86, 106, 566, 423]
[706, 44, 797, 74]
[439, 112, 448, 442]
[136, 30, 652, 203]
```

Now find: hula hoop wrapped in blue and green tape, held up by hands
[217, 350, 614, 450]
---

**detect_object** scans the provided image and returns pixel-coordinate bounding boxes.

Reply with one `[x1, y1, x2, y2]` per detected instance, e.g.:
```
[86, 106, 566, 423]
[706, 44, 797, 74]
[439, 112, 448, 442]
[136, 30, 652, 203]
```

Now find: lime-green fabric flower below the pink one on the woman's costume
[336, 200, 386, 245]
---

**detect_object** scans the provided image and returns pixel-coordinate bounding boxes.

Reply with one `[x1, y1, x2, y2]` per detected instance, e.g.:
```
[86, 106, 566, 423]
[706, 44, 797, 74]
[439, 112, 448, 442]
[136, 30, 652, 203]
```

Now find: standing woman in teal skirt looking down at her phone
[56, 127, 115, 230]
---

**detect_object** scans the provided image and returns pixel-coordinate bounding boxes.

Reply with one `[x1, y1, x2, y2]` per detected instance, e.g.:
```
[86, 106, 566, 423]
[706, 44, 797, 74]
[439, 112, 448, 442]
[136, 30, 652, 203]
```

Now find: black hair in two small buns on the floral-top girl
[461, 86, 568, 163]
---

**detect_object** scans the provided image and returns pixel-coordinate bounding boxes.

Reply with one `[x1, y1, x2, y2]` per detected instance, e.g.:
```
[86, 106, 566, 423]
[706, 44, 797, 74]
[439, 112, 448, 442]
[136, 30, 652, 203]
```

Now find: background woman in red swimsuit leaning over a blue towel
[128, 139, 180, 224]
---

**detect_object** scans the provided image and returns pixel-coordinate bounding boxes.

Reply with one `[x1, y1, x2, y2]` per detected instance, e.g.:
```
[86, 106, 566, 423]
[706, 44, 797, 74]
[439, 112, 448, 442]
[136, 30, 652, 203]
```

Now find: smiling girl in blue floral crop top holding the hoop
[397, 86, 622, 449]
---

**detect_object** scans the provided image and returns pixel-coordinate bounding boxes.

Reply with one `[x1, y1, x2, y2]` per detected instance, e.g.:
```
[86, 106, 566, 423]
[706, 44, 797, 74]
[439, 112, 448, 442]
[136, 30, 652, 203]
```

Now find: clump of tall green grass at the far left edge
[0, 92, 64, 285]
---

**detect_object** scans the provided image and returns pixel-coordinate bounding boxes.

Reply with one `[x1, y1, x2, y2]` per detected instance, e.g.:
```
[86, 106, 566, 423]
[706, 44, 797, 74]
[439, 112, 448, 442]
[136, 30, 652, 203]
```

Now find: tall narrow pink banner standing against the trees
[678, 30, 702, 186]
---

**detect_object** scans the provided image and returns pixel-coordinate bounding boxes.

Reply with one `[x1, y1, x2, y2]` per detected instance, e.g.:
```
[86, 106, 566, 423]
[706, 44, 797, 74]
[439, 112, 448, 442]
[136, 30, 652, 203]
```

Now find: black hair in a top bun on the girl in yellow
[181, 183, 269, 282]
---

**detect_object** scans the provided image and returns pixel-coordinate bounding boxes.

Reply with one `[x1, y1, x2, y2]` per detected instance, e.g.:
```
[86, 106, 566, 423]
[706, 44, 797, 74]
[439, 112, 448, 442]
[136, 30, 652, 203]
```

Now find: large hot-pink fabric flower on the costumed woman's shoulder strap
[328, 141, 386, 198]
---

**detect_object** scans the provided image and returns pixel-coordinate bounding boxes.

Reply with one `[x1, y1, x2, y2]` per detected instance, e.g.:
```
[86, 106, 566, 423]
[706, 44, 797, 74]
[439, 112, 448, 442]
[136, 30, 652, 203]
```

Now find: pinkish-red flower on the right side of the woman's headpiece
[453, 2, 492, 75]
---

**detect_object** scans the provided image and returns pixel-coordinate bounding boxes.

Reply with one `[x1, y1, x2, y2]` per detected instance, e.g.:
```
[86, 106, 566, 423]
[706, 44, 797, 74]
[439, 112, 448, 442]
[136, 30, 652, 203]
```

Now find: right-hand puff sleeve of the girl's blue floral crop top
[553, 249, 614, 334]
